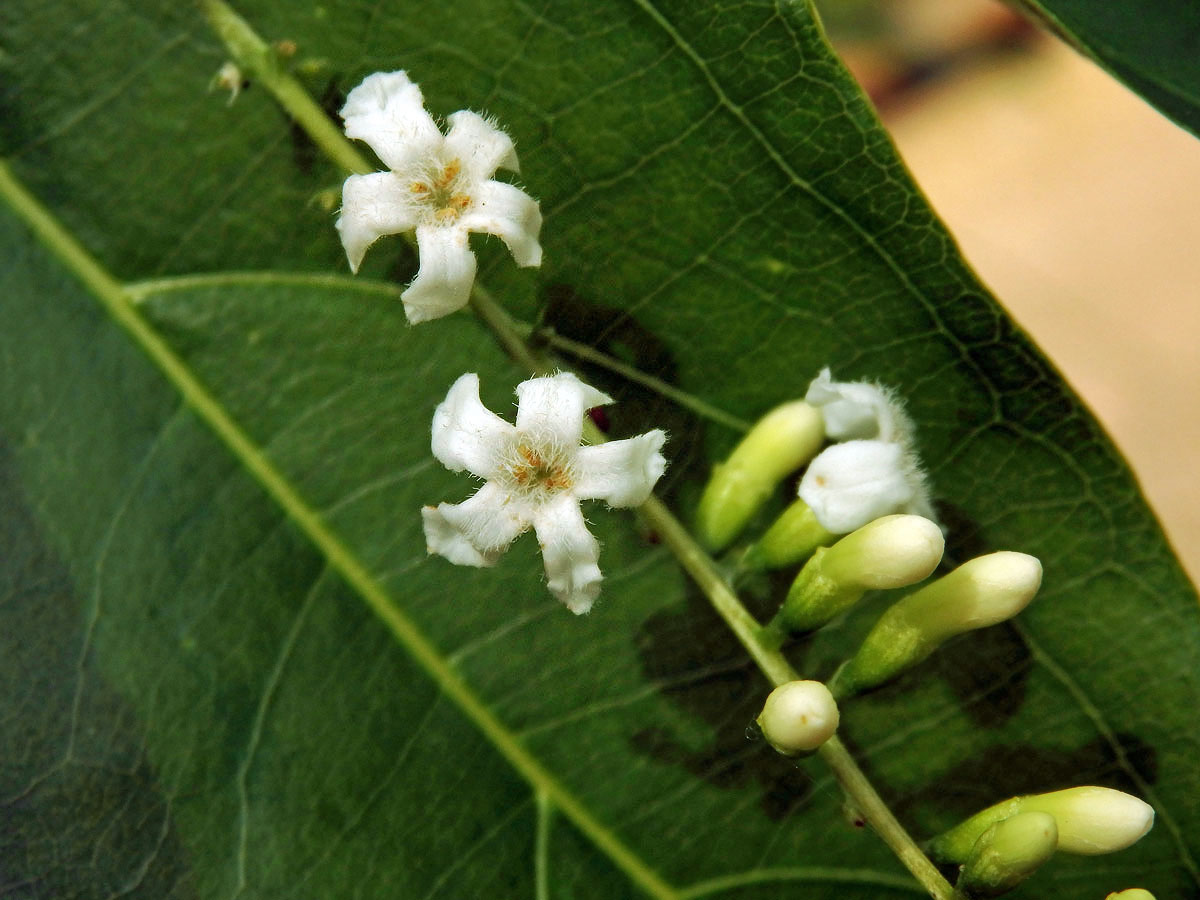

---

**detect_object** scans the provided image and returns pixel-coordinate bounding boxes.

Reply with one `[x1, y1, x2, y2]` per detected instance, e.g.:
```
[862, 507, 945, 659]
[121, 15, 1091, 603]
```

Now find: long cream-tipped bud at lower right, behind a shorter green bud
[929, 786, 1154, 863]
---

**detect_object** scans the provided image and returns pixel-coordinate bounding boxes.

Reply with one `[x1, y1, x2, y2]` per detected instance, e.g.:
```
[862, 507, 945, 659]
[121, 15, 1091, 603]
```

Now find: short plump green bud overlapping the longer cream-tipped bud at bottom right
[956, 812, 1058, 896]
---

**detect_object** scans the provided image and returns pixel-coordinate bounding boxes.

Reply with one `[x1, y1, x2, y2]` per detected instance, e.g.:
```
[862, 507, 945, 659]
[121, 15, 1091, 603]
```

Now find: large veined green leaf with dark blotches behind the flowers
[0, 0, 1200, 900]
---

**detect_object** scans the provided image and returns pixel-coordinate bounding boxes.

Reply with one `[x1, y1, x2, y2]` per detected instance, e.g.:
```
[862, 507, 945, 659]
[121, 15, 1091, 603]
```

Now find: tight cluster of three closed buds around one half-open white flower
[697, 368, 1042, 697]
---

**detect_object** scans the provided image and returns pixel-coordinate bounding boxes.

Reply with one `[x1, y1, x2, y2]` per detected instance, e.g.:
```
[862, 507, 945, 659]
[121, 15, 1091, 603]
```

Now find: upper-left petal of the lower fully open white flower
[432, 372, 516, 479]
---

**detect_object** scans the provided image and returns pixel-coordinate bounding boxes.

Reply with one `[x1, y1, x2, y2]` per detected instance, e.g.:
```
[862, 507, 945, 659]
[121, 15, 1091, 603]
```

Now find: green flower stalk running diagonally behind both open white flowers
[201, 8, 959, 900]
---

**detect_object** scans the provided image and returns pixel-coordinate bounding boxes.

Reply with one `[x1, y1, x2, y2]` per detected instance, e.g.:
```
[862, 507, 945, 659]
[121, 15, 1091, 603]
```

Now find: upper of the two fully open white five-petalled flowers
[337, 72, 541, 323]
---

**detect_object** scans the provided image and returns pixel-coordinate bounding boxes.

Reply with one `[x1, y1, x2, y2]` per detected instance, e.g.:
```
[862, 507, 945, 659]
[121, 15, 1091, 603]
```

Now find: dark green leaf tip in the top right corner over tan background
[1018, 0, 1200, 134]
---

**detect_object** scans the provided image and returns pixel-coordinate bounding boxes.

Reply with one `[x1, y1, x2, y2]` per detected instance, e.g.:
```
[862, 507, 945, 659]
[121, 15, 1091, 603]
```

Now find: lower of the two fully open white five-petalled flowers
[421, 373, 666, 613]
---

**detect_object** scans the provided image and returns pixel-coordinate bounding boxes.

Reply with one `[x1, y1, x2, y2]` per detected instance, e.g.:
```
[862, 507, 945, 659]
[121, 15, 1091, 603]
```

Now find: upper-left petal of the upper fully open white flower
[342, 72, 443, 169]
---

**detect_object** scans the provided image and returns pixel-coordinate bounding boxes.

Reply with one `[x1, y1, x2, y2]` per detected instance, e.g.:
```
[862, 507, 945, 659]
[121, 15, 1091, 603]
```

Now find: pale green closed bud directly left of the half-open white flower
[696, 400, 824, 551]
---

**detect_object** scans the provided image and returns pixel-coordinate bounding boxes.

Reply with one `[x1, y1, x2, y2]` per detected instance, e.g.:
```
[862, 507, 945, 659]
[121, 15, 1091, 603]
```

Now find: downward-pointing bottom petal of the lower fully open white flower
[533, 494, 604, 616]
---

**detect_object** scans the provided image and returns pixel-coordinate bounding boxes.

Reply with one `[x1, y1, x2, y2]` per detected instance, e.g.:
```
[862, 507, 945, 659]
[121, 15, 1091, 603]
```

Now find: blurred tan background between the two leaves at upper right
[817, 0, 1200, 582]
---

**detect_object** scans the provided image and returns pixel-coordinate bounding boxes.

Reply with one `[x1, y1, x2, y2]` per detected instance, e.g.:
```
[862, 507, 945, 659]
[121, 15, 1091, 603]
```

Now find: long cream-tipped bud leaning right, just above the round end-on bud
[834, 551, 1042, 697]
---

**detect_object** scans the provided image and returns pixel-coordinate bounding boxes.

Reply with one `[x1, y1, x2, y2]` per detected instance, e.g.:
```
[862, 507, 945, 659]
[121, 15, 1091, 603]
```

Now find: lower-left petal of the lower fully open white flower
[421, 482, 529, 566]
